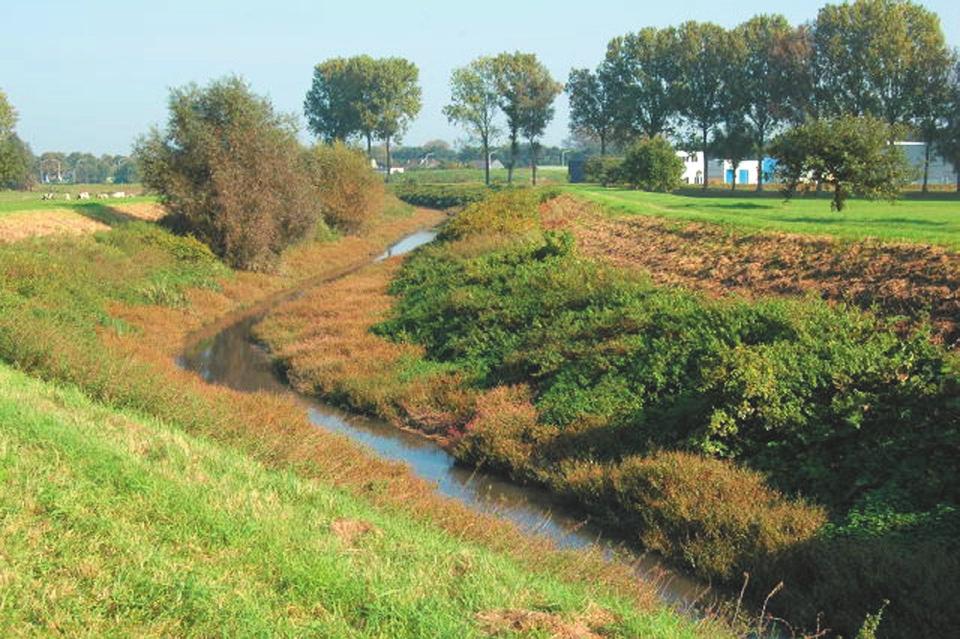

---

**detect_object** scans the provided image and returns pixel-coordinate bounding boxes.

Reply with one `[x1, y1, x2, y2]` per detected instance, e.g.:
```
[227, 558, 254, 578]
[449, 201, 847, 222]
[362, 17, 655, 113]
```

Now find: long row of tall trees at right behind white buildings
[566, 0, 960, 191]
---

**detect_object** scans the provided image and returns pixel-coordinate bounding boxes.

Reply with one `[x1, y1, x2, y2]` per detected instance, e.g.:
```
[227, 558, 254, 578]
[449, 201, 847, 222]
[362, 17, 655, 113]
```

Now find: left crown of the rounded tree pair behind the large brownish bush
[303, 58, 363, 142]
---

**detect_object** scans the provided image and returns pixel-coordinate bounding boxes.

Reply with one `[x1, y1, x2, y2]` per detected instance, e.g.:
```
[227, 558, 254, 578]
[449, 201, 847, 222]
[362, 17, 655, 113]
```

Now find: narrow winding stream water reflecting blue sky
[178, 231, 704, 606]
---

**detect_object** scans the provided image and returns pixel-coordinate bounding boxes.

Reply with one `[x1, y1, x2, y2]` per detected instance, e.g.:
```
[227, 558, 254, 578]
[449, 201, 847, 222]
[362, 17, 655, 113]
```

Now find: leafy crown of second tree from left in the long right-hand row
[602, 27, 679, 139]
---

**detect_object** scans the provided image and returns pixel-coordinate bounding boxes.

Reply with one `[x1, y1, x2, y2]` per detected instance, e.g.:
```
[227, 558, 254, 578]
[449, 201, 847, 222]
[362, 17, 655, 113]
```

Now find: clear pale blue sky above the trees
[0, 0, 960, 154]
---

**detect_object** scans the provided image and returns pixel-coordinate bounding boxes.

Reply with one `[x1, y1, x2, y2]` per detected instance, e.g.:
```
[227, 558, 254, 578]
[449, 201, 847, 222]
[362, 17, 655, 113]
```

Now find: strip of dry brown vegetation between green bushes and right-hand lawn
[544, 196, 960, 348]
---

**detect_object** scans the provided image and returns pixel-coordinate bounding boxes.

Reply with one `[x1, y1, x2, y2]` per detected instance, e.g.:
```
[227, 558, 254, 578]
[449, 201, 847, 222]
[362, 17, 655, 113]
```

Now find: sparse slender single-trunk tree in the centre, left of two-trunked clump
[443, 57, 500, 185]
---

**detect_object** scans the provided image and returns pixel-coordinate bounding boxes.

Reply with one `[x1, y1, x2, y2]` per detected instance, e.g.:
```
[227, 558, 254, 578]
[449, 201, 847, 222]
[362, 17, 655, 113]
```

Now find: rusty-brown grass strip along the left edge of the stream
[95, 211, 704, 637]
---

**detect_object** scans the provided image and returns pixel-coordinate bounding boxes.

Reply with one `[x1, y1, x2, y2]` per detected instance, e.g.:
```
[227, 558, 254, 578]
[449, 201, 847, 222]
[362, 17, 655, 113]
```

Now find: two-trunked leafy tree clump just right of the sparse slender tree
[493, 51, 563, 184]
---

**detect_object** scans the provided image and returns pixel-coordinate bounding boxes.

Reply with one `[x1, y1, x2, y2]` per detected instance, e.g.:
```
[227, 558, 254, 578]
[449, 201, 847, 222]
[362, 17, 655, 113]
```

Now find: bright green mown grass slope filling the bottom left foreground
[0, 365, 693, 637]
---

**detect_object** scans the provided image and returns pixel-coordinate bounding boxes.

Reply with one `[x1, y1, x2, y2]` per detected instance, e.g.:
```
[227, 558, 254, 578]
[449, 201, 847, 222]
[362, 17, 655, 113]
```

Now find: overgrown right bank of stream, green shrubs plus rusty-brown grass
[253, 193, 958, 636]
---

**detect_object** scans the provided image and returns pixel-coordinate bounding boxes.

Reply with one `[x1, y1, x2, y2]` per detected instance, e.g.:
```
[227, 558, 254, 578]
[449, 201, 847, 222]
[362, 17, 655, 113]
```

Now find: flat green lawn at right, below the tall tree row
[565, 185, 960, 249]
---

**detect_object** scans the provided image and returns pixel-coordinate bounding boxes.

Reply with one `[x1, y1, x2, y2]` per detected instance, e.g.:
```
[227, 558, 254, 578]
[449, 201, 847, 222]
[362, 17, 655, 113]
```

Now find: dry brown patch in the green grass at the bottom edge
[477, 606, 616, 639]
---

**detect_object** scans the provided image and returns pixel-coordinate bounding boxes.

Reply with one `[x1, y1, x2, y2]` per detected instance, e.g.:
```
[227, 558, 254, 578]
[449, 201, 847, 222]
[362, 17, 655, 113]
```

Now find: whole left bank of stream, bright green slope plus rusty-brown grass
[0, 205, 712, 637]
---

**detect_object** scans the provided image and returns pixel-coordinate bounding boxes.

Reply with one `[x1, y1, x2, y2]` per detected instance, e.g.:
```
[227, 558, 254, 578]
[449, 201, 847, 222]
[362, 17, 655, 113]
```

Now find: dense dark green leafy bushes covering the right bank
[381, 234, 960, 509]
